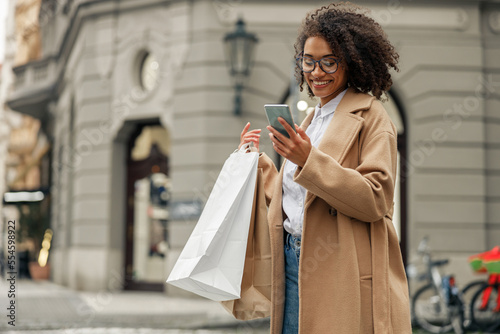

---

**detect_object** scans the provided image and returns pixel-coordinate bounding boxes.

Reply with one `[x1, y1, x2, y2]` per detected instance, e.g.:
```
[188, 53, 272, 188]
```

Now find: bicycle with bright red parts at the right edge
[469, 246, 500, 332]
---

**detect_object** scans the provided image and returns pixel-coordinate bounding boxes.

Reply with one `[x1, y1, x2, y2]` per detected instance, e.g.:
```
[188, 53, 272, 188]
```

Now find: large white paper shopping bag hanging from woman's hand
[167, 148, 259, 301]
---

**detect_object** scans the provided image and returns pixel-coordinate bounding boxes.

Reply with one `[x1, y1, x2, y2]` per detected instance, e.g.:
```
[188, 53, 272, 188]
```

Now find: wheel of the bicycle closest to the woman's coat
[411, 284, 453, 334]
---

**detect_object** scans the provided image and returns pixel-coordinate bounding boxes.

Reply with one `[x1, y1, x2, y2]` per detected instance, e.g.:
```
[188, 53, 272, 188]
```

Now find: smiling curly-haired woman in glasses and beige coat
[240, 3, 411, 334]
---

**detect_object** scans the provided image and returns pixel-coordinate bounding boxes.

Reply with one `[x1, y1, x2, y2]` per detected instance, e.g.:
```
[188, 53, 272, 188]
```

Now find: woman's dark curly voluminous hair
[294, 2, 399, 100]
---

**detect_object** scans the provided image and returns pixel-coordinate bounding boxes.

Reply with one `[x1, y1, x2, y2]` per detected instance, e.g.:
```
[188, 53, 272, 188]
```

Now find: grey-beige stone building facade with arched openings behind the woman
[3, 0, 500, 290]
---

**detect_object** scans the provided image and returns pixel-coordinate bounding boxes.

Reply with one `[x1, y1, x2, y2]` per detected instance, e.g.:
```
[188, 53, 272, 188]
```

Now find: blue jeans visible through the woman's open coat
[282, 231, 300, 334]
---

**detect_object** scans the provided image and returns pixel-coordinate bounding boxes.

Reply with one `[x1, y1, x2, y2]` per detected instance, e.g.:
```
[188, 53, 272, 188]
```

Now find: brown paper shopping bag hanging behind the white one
[221, 169, 271, 320]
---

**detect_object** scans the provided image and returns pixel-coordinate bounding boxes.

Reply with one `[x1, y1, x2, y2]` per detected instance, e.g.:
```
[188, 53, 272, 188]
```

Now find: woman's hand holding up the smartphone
[267, 117, 312, 167]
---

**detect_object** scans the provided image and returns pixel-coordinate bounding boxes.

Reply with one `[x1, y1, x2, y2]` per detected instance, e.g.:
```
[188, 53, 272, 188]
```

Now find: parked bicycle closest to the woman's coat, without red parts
[411, 237, 466, 334]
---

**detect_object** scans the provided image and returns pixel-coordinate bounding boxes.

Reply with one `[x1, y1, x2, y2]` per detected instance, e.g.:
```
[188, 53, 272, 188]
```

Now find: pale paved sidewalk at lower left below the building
[0, 280, 269, 334]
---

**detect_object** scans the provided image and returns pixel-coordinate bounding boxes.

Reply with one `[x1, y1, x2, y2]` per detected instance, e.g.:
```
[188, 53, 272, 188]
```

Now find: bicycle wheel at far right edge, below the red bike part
[470, 284, 500, 332]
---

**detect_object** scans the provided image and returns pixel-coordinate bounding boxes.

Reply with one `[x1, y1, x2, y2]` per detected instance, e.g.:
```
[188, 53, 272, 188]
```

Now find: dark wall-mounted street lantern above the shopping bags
[224, 19, 258, 115]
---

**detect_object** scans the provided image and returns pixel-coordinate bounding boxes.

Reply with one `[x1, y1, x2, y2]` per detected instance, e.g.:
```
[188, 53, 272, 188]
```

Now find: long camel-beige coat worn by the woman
[259, 89, 411, 334]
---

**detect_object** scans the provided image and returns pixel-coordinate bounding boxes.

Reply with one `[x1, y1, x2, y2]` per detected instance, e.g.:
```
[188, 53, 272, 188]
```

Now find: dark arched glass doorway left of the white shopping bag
[125, 123, 170, 291]
